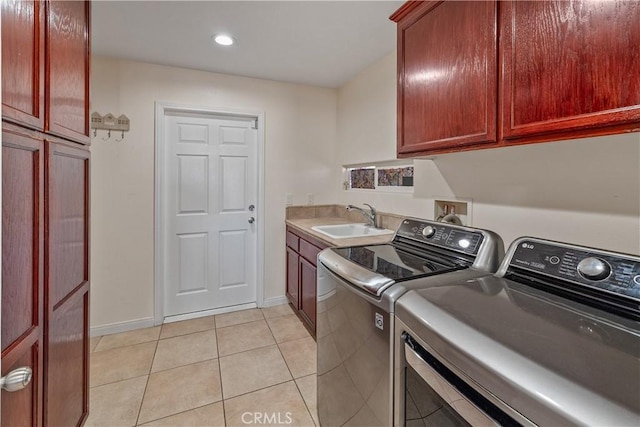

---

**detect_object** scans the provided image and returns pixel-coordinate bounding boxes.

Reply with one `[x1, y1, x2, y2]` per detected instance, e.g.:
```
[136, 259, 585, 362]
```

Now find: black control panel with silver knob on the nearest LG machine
[509, 239, 640, 299]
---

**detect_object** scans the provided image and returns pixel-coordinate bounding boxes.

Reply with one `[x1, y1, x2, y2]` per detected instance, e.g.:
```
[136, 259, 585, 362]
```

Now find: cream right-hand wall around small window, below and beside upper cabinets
[334, 53, 640, 254]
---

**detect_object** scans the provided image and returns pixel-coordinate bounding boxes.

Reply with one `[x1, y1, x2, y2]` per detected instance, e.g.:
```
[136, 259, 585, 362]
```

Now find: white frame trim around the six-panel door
[153, 101, 265, 326]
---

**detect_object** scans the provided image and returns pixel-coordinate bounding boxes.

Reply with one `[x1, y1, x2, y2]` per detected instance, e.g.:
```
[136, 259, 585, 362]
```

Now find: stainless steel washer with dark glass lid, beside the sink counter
[316, 218, 503, 427]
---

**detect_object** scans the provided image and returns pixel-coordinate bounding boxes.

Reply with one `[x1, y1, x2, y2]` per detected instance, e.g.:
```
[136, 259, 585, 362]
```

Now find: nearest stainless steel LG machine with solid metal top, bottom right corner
[395, 238, 640, 426]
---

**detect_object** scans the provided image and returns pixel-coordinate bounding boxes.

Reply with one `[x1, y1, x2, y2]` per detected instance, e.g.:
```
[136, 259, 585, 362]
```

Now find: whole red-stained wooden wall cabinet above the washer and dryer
[391, 0, 640, 157]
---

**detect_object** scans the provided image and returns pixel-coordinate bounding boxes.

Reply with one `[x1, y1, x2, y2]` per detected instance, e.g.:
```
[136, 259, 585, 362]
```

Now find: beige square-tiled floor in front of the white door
[85, 305, 317, 427]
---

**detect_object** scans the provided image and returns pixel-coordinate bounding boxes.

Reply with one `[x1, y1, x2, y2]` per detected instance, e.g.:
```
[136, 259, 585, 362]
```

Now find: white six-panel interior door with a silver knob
[162, 112, 258, 317]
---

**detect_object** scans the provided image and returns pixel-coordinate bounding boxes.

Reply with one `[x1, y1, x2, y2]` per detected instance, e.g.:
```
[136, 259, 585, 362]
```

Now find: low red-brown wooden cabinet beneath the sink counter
[286, 227, 327, 338]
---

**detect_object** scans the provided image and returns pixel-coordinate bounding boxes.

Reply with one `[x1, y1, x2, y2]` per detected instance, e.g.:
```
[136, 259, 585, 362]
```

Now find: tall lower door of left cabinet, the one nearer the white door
[45, 143, 89, 426]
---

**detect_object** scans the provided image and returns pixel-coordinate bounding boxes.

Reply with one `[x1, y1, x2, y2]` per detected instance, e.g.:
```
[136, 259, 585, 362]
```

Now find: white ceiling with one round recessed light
[92, 0, 404, 88]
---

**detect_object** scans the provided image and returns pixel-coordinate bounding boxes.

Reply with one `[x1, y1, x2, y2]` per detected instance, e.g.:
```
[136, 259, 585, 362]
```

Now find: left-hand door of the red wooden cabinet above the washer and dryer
[392, 1, 497, 157]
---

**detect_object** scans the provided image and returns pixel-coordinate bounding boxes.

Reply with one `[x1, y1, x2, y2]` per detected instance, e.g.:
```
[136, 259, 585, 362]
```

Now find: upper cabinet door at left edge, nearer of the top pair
[1, 0, 44, 130]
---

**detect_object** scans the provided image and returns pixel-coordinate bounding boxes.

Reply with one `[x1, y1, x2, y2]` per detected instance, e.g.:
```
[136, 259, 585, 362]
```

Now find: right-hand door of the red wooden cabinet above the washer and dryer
[501, 0, 640, 138]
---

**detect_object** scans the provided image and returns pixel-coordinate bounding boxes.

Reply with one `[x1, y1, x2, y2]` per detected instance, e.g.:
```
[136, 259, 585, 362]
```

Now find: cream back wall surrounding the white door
[91, 56, 336, 328]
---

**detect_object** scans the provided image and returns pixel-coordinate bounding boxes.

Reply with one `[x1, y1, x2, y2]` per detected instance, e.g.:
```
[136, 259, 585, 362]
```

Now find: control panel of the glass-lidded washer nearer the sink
[396, 219, 483, 255]
